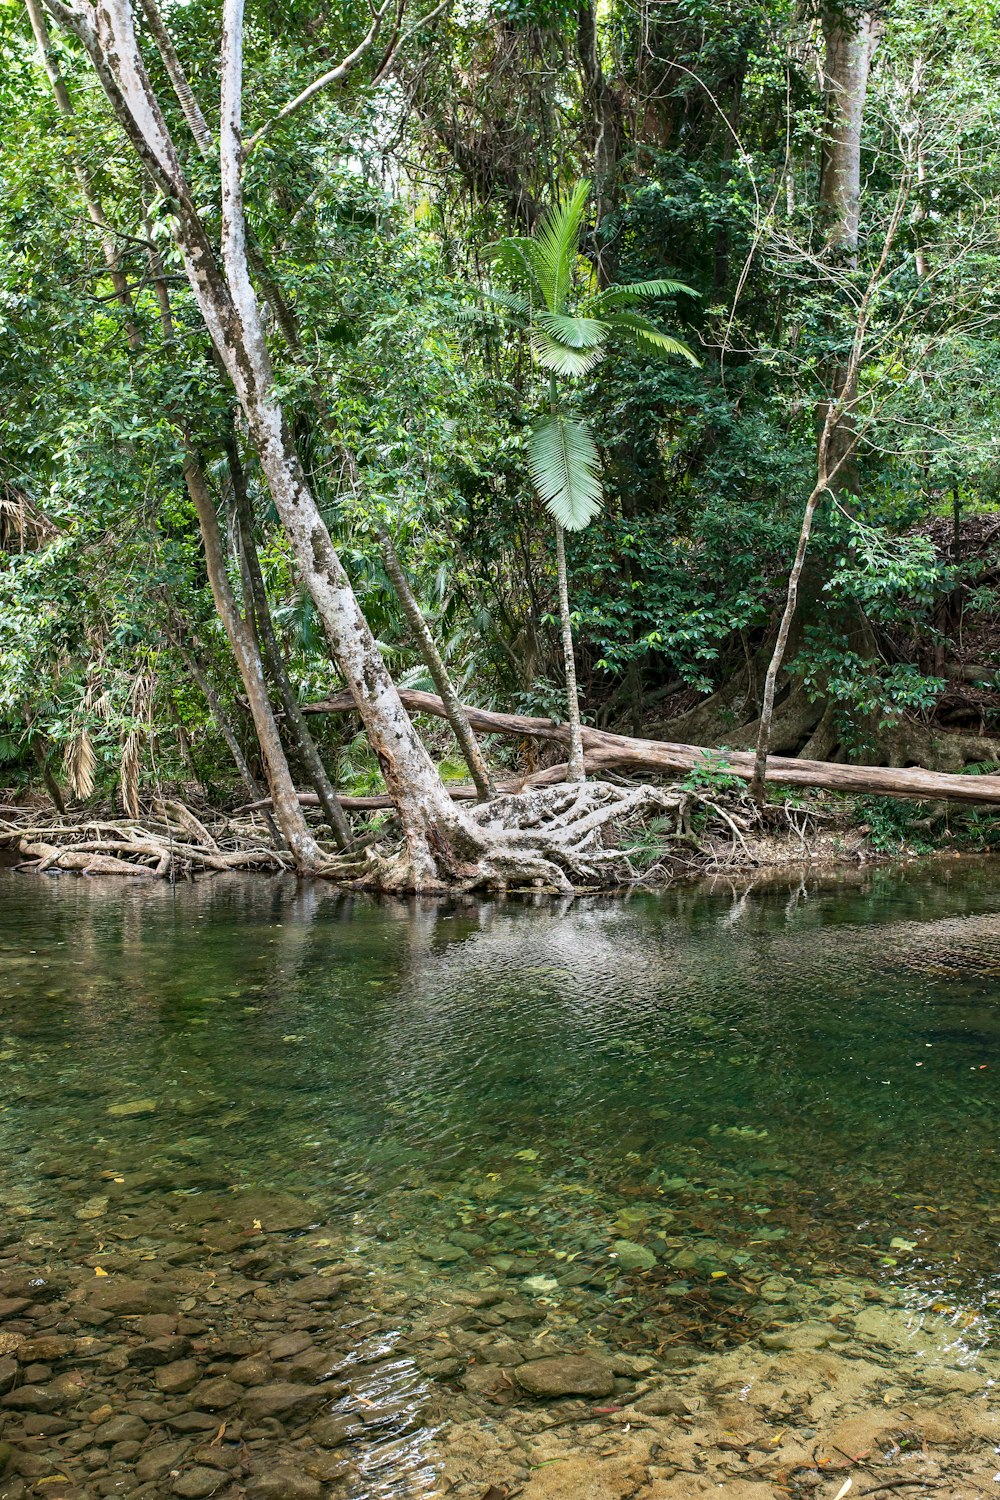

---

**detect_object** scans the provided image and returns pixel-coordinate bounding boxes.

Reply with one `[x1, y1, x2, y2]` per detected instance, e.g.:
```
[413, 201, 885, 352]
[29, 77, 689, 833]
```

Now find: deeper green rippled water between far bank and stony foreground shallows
[0, 861, 1000, 1464]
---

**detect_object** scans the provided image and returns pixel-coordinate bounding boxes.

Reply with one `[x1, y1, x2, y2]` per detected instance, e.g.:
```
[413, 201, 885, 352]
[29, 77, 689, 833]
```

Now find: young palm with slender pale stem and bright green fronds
[477, 179, 699, 782]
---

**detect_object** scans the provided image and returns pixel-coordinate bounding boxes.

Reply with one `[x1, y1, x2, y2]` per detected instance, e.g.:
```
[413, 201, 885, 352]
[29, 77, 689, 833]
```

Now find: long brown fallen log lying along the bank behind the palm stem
[304, 689, 1000, 807]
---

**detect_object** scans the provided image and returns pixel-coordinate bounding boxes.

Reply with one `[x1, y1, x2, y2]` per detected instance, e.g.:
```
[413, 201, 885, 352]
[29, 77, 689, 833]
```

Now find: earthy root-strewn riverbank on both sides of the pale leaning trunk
[0, 785, 996, 894]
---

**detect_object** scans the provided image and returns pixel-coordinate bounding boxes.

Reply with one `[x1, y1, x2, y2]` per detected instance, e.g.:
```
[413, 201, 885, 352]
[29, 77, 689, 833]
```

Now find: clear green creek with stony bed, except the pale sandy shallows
[0, 861, 1000, 1500]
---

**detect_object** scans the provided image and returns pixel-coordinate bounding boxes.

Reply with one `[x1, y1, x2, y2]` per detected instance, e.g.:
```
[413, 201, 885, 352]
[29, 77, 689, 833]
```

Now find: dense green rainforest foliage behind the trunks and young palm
[0, 0, 1000, 807]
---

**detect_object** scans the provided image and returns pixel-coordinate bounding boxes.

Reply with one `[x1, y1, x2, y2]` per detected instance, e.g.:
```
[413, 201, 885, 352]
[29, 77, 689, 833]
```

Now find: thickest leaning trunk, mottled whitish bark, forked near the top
[45, 0, 483, 888]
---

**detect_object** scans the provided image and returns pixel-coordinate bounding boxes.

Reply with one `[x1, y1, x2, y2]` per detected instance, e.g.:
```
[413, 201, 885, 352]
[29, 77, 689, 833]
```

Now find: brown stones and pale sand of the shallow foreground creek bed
[0, 1179, 1000, 1500]
